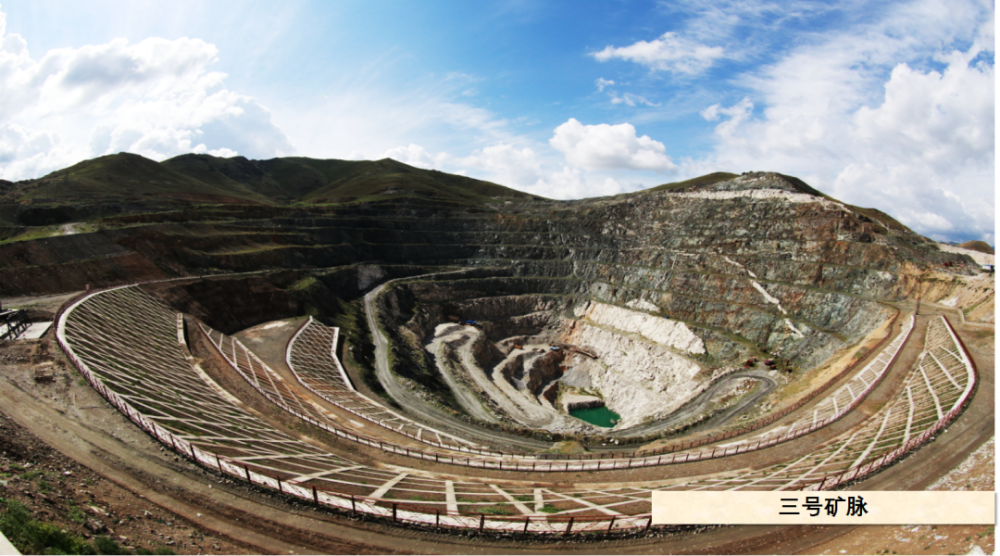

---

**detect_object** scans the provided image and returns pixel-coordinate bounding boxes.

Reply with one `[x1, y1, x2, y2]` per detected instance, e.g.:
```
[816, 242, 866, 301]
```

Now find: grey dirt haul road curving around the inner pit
[364, 270, 778, 451]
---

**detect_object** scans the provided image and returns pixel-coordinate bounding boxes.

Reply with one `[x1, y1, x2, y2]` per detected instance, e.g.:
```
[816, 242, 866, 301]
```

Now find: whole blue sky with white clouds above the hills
[0, 0, 996, 244]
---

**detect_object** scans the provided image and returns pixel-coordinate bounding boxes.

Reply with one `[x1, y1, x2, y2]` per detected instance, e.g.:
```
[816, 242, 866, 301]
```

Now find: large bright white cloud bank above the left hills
[0, 6, 294, 179]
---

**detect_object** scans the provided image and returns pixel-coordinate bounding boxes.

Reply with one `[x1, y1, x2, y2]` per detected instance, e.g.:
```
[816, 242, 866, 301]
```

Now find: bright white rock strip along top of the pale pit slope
[575, 302, 705, 355]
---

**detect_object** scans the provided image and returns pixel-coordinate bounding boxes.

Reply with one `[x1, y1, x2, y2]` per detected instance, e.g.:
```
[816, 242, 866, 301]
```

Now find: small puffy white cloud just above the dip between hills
[549, 119, 677, 171]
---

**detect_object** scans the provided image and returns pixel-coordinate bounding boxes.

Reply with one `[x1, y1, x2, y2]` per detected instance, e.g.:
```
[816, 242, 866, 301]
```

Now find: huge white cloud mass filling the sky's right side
[700, 0, 996, 241]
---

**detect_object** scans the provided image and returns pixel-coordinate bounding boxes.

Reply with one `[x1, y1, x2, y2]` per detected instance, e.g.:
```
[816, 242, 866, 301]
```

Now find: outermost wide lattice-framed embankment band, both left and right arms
[59, 288, 975, 533]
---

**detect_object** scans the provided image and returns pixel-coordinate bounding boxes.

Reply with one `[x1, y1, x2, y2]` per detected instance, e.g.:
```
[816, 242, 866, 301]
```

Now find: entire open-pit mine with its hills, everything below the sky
[0, 155, 996, 555]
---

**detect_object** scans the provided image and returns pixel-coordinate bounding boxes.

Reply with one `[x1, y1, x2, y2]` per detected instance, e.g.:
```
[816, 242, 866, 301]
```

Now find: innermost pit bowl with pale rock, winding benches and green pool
[411, 292, 783, 444]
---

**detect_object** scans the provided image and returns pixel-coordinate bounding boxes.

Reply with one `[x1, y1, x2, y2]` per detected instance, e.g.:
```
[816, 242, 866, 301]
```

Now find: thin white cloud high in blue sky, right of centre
[592, 33, 725, 75]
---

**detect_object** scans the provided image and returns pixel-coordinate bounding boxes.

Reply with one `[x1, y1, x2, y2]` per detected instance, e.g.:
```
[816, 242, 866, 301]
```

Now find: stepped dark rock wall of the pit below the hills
[0, 174, 976, 426]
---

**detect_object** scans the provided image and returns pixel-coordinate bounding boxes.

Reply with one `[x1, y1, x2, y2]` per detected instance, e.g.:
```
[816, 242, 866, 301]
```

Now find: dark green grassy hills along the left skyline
[9, 154, 538, 205]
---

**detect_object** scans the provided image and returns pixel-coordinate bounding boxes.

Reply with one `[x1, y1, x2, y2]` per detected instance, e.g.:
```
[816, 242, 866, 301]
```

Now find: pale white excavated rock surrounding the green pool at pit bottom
[426, 301, 712, 433]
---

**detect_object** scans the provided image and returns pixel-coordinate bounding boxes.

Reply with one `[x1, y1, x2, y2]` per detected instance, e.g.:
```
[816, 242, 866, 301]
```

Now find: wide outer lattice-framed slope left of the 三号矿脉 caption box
[60, 288, 664, 532]
